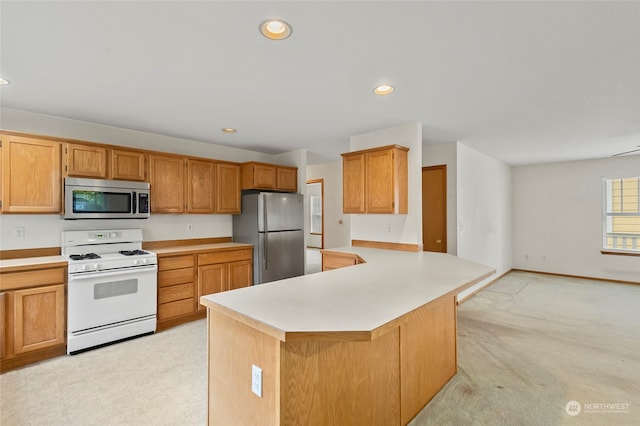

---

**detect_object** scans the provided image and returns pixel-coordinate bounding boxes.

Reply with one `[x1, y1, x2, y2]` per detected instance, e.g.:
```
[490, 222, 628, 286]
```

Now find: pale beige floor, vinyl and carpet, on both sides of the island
[0, 272, 640, 426]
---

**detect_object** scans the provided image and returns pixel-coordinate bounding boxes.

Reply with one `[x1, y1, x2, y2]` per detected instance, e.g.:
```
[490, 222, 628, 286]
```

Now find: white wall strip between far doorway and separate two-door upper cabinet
[307, 161, 351, 248]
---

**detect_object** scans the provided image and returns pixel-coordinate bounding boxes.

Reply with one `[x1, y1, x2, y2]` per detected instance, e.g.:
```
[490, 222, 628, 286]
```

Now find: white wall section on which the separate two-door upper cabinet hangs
[349, 123, 422, 249]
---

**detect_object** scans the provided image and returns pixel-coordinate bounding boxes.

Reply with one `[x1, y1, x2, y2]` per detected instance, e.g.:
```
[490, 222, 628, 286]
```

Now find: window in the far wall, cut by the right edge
[603, 177, 640, 252]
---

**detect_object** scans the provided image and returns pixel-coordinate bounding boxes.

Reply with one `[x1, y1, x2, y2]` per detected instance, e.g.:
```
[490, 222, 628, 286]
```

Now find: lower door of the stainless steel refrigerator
[253, 230, 304, 284]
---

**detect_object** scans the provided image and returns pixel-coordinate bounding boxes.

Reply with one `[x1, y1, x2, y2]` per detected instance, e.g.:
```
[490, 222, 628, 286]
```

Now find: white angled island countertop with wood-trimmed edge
[200, 247, 495, 341]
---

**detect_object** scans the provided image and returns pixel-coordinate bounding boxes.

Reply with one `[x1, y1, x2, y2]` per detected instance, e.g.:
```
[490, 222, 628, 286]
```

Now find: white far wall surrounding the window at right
[513, 155, 640, 282]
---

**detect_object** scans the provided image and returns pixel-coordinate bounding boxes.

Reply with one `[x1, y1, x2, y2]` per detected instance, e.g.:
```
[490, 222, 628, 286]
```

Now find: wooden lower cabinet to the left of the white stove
[0, 267, 66, 372]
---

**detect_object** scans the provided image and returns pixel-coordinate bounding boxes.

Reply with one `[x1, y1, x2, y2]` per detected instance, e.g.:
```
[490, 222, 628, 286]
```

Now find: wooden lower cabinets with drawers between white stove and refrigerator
[157, 247, 253, 330]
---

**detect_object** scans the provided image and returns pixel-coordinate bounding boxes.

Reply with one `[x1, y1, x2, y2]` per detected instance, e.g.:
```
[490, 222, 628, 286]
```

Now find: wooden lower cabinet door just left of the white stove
[13, 284, 65, 354]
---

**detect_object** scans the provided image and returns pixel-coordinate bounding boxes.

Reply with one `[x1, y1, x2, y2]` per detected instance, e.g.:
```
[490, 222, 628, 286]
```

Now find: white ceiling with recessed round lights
[0, 0, 640, 165]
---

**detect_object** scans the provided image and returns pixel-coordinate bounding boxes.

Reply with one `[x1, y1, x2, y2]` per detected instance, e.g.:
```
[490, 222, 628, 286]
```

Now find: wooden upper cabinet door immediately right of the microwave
[149, 155, 185, 213]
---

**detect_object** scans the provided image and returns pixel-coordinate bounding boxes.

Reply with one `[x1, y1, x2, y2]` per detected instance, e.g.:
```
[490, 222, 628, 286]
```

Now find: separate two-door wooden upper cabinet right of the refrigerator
[342, 145, 409, 214]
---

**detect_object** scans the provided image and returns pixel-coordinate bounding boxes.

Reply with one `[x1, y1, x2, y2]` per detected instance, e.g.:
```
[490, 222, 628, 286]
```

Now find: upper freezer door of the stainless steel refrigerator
[258, 192, 304, 232]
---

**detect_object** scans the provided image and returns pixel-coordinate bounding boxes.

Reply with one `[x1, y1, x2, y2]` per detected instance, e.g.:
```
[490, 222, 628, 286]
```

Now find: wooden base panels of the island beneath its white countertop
[208, 296, 456, 425]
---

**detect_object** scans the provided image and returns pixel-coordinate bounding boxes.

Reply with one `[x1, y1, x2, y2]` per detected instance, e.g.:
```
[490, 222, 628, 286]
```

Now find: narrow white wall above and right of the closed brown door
[422, 142, 458, 255]
